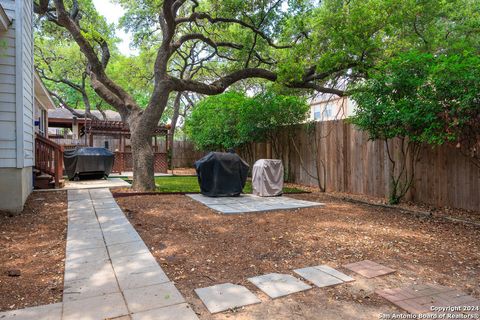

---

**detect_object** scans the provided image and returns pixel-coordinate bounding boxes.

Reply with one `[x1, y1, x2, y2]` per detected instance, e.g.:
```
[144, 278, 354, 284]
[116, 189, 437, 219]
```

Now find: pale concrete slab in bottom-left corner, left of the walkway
[0, 303, 62, 320]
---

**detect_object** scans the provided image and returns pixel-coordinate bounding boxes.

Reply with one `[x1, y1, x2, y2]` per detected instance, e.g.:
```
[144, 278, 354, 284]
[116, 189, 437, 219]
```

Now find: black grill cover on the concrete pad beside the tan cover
[195, 152, 249, 197]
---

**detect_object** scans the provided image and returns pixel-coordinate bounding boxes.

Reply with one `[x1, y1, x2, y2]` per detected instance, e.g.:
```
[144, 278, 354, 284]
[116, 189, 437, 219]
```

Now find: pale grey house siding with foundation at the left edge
[0, 0, 34, 211]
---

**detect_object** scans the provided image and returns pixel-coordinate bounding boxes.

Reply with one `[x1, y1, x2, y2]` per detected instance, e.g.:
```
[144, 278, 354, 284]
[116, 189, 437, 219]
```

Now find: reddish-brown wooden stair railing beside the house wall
[35, 134, 63, 188]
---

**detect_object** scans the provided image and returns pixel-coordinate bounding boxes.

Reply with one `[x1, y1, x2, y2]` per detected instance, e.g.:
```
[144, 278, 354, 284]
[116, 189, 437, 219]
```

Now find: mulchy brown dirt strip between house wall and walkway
[0, 191, 67, 311]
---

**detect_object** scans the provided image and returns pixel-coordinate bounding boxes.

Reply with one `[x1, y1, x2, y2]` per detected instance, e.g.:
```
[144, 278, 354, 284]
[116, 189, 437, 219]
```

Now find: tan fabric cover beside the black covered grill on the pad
[252, 159, 283, 197]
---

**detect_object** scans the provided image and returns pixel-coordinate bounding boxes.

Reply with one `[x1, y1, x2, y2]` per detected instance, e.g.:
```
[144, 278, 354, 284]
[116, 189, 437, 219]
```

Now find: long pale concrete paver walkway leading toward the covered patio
[0, 189, 198, 320]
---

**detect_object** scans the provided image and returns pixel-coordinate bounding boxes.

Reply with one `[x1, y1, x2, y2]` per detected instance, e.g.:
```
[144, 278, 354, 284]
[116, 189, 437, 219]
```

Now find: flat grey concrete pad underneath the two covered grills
[187, 194, 324, 214]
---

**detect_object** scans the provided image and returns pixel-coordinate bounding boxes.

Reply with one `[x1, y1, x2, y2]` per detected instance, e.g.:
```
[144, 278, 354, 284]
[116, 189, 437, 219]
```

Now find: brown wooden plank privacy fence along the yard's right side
[249, 120, 480, 210]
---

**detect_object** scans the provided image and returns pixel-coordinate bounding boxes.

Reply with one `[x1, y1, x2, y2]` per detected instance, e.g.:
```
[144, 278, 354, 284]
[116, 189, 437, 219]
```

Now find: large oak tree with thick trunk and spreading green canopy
[35, 0, 454, 190]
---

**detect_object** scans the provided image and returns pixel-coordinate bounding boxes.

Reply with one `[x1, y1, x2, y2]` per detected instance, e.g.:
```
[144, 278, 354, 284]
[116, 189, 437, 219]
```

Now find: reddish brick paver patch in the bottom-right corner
[375, 284, 480, 319]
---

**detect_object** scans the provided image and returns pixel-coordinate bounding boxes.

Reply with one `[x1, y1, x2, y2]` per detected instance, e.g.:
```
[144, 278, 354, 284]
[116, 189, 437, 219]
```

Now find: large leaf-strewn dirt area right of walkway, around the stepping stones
[117, 193, 480, 320]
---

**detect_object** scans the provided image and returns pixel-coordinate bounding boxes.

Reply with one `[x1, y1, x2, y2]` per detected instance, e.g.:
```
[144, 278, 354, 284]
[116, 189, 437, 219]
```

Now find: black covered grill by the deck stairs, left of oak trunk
[63, 147, 115, 179]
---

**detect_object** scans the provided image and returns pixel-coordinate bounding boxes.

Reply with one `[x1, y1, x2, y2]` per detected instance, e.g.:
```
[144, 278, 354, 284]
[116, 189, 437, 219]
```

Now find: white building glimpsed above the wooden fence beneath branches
[309, 94, 356, 121]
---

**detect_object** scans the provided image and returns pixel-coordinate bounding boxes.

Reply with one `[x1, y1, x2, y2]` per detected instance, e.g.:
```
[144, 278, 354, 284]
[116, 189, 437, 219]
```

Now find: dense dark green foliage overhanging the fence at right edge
[351, 51, 480, 161]
